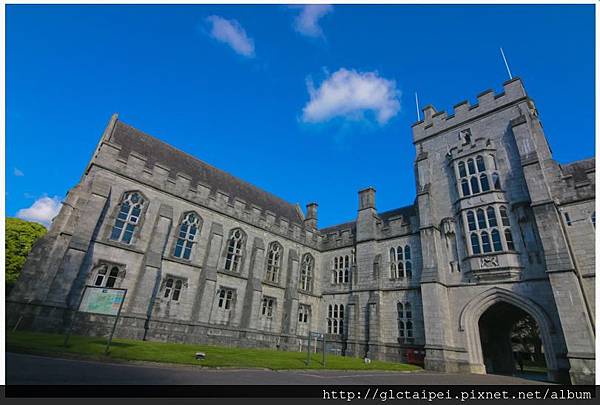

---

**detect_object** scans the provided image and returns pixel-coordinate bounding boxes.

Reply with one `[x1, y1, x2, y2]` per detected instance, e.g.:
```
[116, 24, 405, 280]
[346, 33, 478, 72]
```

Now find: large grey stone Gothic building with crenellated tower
[7, 79, 595, 384]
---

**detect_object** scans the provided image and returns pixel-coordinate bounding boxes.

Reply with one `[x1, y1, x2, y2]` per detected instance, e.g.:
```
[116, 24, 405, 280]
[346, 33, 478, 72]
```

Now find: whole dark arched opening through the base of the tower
[479, 302, 547, 380]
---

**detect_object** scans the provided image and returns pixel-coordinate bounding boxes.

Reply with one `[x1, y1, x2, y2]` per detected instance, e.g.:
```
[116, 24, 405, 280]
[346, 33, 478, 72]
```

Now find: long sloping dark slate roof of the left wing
[108, 121, 303, 224]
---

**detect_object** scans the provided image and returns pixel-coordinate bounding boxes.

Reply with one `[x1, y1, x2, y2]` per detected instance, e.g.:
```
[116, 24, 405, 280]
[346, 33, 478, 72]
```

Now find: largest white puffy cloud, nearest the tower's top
[302, 68, 400, 125]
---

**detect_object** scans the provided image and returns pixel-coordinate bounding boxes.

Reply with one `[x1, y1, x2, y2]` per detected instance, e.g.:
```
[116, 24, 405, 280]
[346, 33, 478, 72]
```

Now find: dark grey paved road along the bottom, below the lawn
[6, 353, 540, 385]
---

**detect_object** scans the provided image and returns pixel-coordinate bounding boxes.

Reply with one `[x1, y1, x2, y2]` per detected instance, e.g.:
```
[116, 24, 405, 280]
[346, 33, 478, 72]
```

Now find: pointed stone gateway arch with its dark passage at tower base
[459, 287, 560, 381]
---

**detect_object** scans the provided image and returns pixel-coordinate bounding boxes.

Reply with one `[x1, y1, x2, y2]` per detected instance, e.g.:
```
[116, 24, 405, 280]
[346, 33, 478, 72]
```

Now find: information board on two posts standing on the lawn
[64, 285, 127, 355]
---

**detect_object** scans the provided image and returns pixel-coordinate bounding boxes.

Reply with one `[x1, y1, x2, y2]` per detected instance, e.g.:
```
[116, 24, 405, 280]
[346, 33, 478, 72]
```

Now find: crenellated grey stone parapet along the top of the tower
[412, 78, 527, 143]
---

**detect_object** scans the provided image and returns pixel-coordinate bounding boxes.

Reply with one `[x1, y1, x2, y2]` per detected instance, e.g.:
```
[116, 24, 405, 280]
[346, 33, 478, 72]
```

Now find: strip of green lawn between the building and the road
[6, 331, 421, 371]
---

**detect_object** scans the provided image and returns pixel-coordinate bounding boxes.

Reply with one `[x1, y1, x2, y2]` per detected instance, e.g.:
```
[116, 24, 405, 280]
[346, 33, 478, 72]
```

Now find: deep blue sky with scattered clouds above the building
[6, 5, 595, 227]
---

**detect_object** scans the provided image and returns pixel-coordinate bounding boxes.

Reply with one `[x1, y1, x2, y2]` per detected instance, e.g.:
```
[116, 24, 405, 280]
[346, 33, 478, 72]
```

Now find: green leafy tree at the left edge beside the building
[4, 218, 48, 295]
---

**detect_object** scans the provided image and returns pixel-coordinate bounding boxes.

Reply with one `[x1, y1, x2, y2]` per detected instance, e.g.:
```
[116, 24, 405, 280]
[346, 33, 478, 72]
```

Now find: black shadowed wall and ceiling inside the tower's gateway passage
[479, 302, 544, 375]
